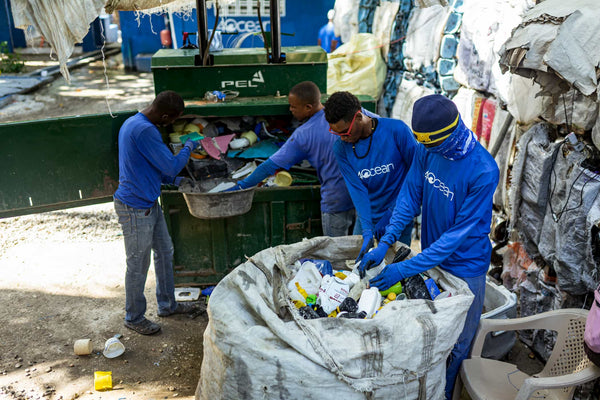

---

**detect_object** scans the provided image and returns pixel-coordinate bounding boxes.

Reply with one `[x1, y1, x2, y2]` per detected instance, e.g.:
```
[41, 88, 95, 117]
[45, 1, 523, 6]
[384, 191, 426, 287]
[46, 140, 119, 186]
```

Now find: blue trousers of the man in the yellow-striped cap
[446, 274, 486, 400]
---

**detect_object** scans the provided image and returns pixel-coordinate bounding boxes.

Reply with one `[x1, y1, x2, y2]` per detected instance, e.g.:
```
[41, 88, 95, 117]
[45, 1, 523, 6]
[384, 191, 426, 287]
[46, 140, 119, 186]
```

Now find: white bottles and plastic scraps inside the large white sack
[287, 249, 452, 319]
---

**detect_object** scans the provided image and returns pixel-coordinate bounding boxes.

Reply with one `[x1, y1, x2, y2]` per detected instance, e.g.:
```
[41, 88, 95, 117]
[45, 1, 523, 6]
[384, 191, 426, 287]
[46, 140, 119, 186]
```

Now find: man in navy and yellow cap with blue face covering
[362, 95, 499, 399]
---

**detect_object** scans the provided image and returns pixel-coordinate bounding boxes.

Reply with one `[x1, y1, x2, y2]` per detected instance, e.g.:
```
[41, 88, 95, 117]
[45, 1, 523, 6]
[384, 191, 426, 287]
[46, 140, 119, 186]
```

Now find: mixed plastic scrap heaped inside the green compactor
[168, 115, 318, 193]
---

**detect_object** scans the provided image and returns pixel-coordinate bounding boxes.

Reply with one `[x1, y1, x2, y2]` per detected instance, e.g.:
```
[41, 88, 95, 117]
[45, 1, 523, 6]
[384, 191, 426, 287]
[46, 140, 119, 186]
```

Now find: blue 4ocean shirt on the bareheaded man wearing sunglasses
[332, 118, 417, 232]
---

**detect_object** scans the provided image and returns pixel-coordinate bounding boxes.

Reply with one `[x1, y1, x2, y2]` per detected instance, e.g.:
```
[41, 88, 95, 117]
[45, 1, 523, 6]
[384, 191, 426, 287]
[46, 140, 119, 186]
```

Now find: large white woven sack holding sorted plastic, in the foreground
[196, 236, 473, 400]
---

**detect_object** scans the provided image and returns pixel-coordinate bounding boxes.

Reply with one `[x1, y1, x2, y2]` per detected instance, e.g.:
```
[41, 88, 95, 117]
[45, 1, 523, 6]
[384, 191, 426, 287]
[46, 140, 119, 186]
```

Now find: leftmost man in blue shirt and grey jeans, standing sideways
[114, 91, 202, 335]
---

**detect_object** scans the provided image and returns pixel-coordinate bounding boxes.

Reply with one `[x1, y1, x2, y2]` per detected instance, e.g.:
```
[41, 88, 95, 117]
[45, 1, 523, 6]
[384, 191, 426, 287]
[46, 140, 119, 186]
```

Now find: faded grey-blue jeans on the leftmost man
[114, 199, 177, 324]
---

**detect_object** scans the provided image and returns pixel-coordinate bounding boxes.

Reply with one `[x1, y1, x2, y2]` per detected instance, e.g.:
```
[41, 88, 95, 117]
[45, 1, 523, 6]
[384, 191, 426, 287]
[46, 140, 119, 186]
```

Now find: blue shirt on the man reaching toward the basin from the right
[269, 110, 353, 213]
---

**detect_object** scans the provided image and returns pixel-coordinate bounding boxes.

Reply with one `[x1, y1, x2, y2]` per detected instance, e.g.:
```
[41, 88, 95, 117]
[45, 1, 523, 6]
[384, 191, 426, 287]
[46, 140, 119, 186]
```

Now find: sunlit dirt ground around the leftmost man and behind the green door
[0, 54, 207, 400]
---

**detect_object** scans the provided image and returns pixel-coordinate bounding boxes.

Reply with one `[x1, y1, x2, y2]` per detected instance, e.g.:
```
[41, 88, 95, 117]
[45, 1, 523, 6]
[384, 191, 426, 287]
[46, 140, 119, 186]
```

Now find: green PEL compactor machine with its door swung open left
[0, 0, 375, 286]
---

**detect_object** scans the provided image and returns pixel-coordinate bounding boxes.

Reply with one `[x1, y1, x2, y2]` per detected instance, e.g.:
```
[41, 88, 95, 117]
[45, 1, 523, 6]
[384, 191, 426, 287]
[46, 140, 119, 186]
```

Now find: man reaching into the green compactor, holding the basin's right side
[227, 81, 354, 236]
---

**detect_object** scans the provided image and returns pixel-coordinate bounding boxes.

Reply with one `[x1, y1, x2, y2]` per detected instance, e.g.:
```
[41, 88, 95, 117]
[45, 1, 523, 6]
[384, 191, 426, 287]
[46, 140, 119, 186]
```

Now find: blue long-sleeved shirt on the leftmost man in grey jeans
[115, 113, 190, 209]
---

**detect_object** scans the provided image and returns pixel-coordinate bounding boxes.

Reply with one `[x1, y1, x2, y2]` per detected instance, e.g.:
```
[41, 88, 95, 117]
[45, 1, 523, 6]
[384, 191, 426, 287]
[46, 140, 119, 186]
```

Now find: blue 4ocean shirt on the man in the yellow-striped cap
[382, 143, 499, 278]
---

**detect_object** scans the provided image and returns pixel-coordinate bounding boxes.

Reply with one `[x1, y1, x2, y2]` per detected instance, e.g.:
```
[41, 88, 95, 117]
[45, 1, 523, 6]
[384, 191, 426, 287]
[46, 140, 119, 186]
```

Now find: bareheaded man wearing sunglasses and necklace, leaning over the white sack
[325, 92, 417, 266]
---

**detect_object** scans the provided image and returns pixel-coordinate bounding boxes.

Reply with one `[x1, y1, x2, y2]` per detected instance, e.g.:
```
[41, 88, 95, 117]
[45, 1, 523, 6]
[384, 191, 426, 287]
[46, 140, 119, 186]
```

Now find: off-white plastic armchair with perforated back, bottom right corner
[452, 309, 600, 400]
